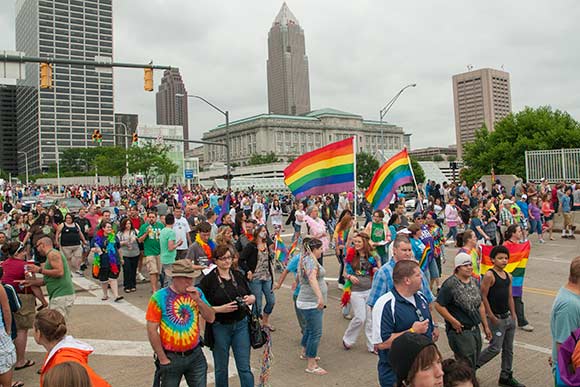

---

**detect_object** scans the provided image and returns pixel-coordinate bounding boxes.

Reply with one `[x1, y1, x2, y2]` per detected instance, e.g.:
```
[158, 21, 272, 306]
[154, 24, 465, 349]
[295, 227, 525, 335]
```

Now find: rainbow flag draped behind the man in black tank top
[481, 241, 530, 297]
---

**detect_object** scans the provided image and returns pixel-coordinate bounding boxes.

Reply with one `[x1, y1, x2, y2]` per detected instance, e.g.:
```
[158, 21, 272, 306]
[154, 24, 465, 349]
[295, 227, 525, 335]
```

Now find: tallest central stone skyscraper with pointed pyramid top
[266, 3, 310, 115]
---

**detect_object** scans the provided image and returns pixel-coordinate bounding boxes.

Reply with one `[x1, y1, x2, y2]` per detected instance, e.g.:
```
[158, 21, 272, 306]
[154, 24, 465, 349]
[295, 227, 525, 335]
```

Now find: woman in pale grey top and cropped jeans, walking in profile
[296, 238, 328, 376]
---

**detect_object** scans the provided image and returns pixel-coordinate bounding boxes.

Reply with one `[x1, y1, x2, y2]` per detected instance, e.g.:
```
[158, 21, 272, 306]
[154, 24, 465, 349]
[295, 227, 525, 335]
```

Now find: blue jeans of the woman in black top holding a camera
[212, 317, 254, 387]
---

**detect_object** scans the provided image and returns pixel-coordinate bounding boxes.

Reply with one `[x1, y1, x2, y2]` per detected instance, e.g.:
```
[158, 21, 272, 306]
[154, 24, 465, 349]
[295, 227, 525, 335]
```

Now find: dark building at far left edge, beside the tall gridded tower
[0, 85, 18, 176]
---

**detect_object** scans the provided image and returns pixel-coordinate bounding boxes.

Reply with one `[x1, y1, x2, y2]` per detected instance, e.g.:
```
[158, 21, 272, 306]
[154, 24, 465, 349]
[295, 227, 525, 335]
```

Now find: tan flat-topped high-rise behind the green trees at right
[453, 69, 512, 159]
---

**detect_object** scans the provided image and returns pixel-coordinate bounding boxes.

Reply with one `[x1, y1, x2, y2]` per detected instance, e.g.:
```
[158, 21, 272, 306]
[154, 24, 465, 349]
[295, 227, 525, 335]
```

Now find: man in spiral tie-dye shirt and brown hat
[145, 259, 215, 387]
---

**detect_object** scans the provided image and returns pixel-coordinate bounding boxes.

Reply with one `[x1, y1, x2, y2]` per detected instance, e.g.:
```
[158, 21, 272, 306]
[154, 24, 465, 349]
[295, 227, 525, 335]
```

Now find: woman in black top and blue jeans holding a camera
[199, 244, 256, 387]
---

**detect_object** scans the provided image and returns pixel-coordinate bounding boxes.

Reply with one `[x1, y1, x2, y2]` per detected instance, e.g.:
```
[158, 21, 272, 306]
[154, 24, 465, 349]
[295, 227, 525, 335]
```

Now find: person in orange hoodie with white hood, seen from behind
[34, 309, 111, 387]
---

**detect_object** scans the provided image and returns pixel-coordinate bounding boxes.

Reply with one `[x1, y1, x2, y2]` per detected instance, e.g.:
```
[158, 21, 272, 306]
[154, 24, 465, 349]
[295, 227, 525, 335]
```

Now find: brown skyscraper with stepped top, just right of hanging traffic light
[155, 68, 189, 150]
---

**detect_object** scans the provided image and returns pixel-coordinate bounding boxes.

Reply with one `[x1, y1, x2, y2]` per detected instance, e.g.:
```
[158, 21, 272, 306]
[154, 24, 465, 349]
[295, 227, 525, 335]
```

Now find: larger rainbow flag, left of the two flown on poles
[284, 137, 355, 199]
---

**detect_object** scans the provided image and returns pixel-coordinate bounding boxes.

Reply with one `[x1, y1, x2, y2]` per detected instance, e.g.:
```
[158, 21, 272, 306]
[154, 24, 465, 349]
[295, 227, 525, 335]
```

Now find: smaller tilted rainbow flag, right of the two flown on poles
[365, 148, 413, 210]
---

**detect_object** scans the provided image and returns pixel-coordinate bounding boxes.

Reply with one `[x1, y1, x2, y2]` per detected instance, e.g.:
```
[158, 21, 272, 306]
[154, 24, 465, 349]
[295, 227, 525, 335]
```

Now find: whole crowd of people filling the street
[0, 180, 580, 387]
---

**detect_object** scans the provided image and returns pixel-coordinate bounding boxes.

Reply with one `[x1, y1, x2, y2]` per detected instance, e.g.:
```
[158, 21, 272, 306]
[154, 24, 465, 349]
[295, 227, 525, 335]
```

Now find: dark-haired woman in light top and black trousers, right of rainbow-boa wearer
[118, 218, 141, 293]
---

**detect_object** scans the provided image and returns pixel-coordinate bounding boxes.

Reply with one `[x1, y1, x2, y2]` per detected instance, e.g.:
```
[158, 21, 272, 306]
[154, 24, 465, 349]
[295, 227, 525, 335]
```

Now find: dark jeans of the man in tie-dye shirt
[157, 345, 207, 387]
